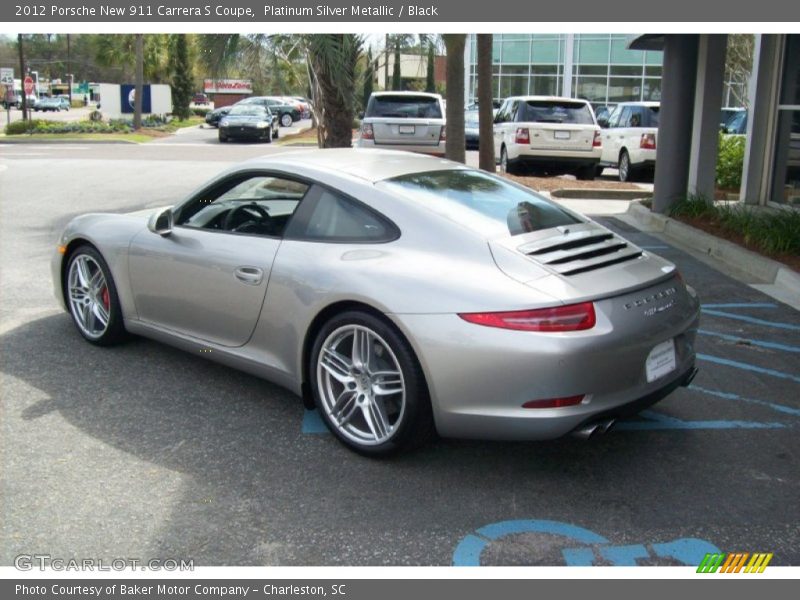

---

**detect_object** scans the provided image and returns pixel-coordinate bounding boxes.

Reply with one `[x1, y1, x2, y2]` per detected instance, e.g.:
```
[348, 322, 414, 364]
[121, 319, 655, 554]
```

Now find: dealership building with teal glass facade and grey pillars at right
[465, 34, 800, 212]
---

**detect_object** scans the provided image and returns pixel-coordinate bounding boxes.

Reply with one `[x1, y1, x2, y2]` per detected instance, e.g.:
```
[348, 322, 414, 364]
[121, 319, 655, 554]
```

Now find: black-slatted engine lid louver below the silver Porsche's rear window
[518, 228, 642, 275]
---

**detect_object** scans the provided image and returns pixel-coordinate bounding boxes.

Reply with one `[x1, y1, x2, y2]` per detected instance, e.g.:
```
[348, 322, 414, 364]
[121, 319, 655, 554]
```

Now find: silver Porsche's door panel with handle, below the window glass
[128, 227, 281, 347]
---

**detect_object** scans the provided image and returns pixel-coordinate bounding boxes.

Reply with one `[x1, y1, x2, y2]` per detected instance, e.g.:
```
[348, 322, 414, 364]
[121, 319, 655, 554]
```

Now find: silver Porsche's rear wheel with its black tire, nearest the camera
[309, 311, 433, 456]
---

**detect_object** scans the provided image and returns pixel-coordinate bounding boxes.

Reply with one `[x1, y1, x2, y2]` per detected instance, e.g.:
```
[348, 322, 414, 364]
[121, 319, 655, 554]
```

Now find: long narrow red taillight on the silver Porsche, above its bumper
[458, 302, 597, 332]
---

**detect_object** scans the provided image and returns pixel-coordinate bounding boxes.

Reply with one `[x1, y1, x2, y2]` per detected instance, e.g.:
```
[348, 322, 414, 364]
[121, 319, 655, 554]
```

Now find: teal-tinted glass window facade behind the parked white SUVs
[467, 33, 662, 104]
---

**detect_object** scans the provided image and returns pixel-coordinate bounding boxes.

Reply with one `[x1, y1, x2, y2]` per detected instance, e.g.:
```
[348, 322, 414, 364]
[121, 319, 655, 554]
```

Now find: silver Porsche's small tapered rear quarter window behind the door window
[287, 186, 399, 242]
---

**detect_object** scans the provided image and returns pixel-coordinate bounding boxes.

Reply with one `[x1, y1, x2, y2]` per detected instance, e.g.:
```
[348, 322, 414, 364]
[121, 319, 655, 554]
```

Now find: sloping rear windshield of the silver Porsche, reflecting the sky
[378, 169, 581, 235]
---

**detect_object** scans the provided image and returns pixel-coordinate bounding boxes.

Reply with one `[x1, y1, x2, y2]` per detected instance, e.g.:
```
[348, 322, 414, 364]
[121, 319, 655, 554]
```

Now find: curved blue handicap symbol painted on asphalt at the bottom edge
[453, 519, 720, 567]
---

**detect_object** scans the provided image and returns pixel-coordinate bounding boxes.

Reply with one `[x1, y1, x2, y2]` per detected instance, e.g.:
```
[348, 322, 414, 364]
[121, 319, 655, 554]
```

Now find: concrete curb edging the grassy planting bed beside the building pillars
[626, 202, 800, 295]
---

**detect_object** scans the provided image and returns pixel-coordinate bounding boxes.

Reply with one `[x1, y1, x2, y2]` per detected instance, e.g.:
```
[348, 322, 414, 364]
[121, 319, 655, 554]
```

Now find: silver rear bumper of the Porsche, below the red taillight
[393, 282, 699, 440]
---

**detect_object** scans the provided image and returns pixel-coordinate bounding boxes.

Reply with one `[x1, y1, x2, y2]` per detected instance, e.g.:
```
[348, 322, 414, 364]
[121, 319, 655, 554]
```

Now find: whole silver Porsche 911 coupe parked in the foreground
[52, 149, 699, 455]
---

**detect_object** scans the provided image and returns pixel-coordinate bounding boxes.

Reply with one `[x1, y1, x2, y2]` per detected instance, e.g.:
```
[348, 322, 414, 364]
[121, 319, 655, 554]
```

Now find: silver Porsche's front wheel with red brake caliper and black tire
[65, 245, 125, 346]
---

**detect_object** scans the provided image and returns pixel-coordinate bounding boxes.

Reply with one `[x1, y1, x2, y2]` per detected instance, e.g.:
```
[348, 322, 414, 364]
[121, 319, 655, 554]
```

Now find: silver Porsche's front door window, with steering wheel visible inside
[175, 173, 309, 237]
